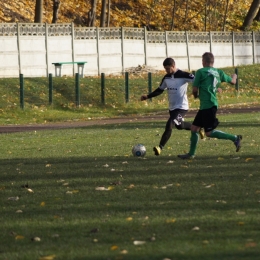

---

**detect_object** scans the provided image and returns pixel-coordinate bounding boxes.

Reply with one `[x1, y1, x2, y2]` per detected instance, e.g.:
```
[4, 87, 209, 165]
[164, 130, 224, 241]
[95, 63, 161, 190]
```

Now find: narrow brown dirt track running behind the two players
[0, 106, 260, 134]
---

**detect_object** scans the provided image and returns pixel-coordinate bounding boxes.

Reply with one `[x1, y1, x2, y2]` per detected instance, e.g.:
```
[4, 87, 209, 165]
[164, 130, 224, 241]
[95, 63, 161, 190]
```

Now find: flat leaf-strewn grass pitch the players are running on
[0, 113, 260, 260]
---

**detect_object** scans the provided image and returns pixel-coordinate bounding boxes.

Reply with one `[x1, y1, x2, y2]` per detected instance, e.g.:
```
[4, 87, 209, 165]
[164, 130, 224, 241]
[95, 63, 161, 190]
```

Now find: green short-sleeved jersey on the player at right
[193, 67, 232, 110]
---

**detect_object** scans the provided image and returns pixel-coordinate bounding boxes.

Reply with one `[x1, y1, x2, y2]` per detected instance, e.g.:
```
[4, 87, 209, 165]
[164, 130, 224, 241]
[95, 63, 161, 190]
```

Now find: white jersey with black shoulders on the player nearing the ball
[159, 69, 195, 110]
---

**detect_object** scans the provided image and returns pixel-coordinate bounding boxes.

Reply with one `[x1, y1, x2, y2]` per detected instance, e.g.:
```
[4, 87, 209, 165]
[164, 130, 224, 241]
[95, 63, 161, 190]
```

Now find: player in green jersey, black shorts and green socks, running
[178, 52, 242, 159]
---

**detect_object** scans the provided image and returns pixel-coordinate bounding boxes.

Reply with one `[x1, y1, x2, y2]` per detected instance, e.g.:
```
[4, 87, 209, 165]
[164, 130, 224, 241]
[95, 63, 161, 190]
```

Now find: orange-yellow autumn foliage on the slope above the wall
[0, 0, 260, 31]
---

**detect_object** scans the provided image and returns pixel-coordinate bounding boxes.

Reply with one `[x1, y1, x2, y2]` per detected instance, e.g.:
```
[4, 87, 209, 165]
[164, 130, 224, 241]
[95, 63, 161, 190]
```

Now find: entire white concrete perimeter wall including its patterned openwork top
[0, 23, 260, 77]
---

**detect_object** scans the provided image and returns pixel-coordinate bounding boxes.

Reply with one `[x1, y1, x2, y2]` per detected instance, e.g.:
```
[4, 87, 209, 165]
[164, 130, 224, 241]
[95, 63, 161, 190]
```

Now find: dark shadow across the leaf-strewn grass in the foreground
[0, 155, 260, 260]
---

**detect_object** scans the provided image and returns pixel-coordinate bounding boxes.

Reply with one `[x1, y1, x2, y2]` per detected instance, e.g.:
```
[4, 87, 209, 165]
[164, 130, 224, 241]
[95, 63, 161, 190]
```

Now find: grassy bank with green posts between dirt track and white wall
[0, 64, 260, 125]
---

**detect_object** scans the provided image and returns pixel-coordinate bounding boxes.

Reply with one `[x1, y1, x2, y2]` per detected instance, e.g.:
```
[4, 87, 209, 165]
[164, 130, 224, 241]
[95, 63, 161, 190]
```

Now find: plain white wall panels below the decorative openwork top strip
[0, 30, 260, 77]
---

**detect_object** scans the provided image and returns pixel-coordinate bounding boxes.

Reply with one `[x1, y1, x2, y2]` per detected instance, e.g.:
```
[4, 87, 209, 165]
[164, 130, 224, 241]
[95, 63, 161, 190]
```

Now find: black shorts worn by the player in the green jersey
[192, 106, 219, 132]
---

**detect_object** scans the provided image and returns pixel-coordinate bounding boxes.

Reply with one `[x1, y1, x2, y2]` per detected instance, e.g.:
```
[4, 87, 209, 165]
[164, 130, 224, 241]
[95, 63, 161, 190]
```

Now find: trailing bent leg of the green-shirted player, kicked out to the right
[204, 107, 242, 152]
